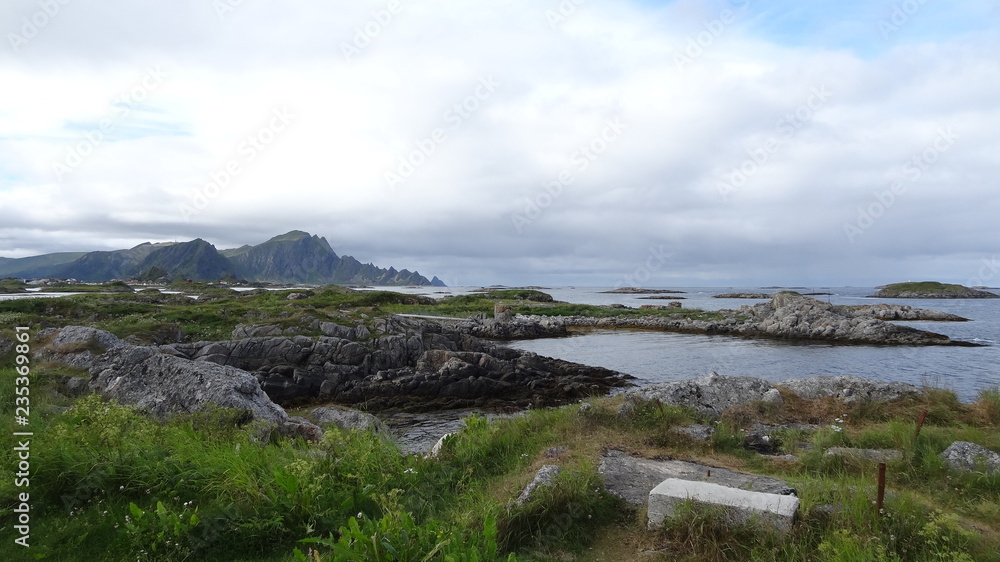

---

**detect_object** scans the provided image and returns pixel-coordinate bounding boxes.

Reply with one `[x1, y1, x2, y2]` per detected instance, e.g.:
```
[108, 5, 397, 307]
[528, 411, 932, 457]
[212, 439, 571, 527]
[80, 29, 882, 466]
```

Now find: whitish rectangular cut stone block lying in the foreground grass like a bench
[647, 478, 799, 532]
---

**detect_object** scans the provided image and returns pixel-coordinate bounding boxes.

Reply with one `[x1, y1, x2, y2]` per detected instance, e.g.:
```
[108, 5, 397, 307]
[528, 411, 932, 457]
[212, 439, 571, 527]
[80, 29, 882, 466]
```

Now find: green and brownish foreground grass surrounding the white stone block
[0, 368, 1000, 561]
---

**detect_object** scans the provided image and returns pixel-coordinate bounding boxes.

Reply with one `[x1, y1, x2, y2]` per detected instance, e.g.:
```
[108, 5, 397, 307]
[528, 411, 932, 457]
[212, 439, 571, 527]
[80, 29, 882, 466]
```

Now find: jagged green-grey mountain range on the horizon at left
[0, 230, 444, 286]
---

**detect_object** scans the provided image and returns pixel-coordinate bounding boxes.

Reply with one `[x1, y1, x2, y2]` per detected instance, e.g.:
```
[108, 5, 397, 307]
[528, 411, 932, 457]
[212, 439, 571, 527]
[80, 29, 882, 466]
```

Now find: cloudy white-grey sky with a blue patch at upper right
[0, 0, 1000, 287]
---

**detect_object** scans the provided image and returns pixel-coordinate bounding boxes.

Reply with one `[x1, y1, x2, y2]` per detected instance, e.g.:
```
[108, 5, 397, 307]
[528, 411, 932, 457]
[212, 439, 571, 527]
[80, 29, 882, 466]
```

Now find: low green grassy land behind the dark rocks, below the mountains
[0, 283, 720, 343]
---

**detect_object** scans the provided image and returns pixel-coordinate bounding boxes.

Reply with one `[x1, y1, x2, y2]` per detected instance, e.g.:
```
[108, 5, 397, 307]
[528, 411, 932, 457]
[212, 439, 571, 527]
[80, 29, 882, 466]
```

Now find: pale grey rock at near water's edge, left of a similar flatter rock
[625, 372, 780, 418]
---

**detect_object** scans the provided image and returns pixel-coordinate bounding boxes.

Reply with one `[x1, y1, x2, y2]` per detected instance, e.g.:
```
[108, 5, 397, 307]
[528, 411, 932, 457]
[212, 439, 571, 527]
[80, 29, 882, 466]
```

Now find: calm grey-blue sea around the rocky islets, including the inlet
[0, 287, 1000, 401]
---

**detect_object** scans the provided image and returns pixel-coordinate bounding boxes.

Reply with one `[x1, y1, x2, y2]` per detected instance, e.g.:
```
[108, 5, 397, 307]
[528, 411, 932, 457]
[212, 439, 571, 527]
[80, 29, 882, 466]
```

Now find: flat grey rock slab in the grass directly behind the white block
[598, 450, 795, 506]
